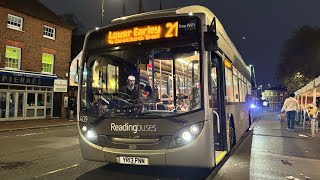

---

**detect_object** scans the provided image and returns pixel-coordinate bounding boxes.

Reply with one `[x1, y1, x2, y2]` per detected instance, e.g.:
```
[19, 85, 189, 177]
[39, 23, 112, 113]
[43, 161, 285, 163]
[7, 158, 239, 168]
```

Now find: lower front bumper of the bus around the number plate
[80, 121, 215, 168]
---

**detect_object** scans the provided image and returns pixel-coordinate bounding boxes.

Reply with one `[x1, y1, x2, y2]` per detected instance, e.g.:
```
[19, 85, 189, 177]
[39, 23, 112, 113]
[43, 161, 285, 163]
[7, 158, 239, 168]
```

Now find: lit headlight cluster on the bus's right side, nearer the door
[169, 122, 203, 148]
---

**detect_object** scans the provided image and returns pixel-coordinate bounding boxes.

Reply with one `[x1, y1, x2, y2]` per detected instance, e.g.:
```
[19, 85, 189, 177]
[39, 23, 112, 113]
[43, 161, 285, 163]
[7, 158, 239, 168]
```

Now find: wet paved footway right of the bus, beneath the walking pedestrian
[214, 112, 320, 180]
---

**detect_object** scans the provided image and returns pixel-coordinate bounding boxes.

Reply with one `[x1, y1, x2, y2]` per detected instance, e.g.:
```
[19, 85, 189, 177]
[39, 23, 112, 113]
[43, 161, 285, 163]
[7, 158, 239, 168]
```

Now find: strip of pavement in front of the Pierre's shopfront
[0, 119, 77, 132]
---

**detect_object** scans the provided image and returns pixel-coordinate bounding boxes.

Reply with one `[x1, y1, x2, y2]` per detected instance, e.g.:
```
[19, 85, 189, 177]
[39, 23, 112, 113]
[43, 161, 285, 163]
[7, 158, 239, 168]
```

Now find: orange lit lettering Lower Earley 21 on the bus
[106, 22, 178, 45]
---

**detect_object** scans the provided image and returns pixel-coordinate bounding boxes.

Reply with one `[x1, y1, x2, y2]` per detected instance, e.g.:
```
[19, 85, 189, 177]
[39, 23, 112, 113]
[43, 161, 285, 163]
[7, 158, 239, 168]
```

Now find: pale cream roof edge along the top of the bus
[111, 5, 250, 76]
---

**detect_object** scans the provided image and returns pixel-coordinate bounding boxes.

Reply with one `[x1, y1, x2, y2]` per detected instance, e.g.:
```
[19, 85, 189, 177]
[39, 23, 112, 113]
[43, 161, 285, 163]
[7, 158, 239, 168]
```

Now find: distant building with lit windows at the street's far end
[262, 87, 288, 110]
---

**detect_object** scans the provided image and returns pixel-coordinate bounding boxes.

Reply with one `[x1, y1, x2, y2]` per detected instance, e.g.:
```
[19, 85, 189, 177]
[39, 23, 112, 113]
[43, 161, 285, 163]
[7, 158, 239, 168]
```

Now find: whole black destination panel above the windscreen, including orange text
[87, 16, 201, 49]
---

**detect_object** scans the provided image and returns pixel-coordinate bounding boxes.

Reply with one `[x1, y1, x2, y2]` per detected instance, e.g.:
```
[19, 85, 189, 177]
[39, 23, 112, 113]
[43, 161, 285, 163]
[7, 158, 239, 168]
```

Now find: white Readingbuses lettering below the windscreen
[110, 123, 157, 134]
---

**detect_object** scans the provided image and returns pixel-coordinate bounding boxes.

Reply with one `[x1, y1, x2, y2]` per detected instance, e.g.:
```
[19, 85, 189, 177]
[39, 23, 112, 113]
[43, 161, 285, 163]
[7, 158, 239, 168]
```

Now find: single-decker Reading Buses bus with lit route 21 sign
[77, 6, 251, 168]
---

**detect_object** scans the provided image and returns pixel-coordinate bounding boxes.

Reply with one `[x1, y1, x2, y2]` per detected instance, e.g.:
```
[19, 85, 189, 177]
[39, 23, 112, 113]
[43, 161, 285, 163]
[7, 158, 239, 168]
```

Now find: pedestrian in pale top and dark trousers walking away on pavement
[281, 93, 299, 131]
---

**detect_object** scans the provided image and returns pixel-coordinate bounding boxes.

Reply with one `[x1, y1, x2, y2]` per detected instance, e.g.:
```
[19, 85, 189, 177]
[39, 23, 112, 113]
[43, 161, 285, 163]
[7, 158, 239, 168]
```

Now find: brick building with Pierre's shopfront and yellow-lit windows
[0, 0, 72, 121]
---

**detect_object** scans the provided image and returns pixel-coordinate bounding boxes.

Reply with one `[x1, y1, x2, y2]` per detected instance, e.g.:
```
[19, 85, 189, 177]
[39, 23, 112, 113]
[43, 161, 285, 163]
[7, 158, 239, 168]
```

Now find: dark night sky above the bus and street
[40, 0, 320, 86]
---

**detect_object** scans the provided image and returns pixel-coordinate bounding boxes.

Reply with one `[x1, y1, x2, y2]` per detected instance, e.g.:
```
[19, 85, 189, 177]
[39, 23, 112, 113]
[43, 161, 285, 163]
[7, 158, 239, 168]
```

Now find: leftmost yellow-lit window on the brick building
[5, 46, 21, 69]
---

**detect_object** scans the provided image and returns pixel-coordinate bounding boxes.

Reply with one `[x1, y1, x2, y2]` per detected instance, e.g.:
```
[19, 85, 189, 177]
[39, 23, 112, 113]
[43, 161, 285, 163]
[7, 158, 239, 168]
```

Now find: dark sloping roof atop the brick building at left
[0, 0, 73, 29]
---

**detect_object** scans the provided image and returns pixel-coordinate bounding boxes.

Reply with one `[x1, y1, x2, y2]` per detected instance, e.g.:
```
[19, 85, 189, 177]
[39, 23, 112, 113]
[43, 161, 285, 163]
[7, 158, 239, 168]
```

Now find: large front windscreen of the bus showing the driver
[81, 47, 201, 116]
